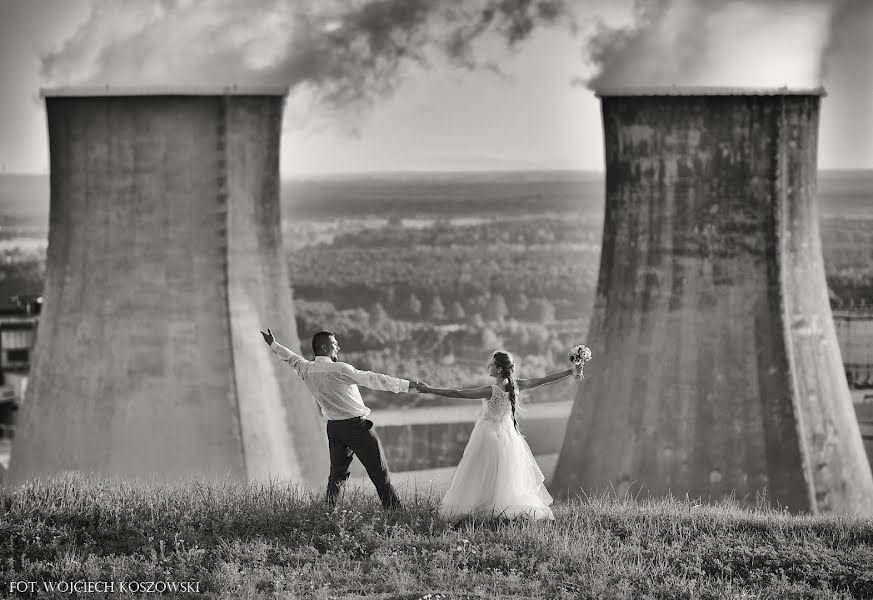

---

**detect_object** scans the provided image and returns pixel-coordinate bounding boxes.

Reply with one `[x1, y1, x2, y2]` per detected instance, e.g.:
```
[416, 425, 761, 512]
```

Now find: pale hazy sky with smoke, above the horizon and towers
[0, 0, 873, 177]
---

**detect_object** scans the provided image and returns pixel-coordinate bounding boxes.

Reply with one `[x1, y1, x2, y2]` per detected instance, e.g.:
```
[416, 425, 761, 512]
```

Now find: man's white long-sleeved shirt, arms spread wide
[270, 341, 409, 419]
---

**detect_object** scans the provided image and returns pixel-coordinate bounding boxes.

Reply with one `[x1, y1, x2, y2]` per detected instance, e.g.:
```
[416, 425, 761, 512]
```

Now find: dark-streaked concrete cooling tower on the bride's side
[551, 89, 873, 514]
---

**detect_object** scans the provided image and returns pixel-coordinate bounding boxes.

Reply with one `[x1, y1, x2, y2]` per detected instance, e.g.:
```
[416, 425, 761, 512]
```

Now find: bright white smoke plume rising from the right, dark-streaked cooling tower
[586, 0, 843, 90]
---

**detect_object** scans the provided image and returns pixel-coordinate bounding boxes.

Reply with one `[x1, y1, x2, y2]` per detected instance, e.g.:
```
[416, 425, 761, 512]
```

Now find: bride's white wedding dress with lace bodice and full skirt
[439, 384, 555, 521]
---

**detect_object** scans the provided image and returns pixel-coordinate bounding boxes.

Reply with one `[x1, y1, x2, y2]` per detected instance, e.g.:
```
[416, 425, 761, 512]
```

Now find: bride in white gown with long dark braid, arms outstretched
[419, 352, 574, 521]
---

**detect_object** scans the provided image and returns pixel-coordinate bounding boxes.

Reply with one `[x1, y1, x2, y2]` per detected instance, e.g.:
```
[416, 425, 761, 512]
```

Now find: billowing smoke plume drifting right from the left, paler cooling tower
[42, 0, 567, 118]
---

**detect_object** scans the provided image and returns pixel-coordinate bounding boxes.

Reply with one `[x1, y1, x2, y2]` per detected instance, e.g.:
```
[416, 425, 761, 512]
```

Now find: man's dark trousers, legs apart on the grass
[327, 417, 400, 509]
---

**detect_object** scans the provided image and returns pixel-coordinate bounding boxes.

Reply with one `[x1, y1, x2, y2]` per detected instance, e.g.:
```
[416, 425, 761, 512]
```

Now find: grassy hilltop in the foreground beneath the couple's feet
[0, 475, 873, 599]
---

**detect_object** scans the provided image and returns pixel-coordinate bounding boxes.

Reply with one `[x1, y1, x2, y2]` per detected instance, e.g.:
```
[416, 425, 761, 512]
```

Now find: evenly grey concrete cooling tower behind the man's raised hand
[10, 88, 327, 483]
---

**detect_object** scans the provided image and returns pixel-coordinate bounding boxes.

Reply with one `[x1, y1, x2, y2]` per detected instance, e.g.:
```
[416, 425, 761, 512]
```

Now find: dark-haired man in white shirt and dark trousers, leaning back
[261, 329, 421, 509]
